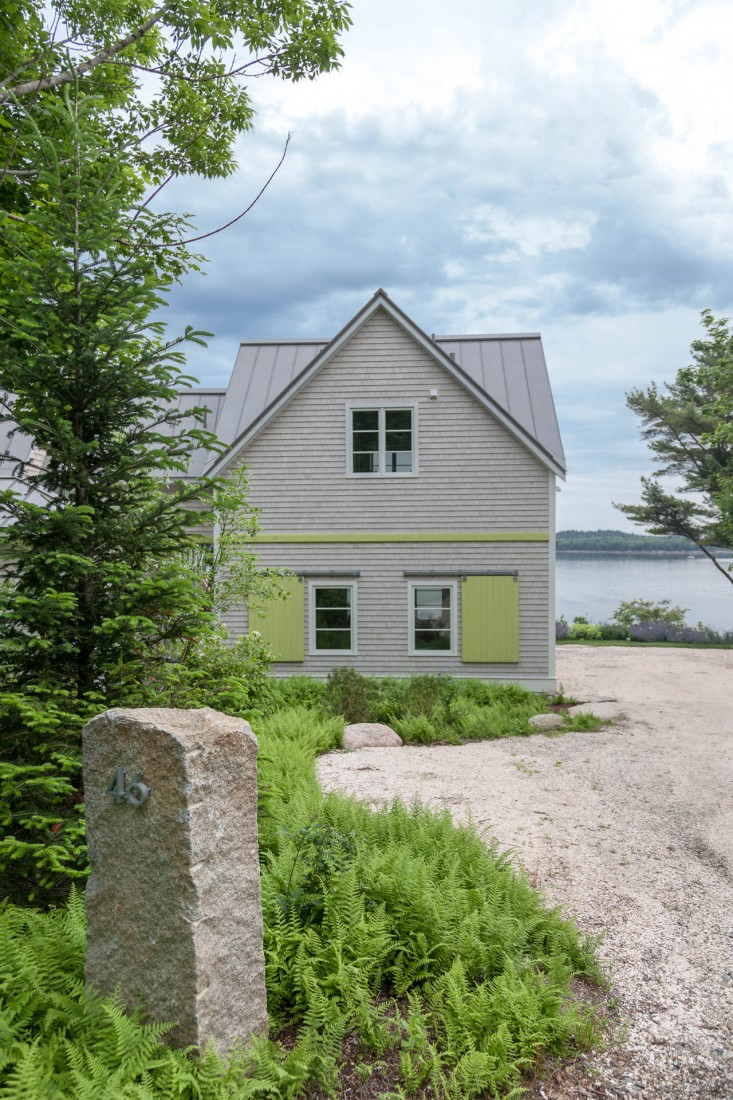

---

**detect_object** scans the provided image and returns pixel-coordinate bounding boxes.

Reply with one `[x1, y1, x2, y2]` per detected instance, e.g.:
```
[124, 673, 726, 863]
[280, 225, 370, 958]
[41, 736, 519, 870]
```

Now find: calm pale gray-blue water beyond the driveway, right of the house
[556, 553, 733, 630]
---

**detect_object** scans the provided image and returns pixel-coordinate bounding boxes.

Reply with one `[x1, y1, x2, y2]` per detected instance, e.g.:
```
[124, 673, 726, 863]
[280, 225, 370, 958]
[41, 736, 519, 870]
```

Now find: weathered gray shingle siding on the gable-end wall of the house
[214, 309, 555, 688]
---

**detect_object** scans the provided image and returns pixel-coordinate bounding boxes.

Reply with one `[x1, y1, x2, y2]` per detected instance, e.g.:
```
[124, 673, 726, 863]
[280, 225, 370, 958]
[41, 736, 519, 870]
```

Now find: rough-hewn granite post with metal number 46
[84, 708, 267, 1054]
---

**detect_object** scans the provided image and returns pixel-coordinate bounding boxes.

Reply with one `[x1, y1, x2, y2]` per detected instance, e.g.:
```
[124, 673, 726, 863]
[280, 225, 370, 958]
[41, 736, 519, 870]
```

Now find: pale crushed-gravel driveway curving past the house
[318, 646, 733, 1100]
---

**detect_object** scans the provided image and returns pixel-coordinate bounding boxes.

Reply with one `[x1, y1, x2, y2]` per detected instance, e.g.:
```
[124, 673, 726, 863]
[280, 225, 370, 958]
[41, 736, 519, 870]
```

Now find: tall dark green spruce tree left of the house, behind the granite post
[0, 89, 275, 900]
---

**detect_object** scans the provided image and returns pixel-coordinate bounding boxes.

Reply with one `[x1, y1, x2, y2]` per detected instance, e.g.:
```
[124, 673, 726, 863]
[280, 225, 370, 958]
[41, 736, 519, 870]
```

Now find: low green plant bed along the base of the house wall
[270, 667, 601, 745]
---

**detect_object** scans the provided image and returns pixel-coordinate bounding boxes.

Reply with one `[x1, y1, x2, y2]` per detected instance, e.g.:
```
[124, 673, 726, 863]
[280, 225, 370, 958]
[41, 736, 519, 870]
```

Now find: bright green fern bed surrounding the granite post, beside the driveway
[0, 704, 597, 1100]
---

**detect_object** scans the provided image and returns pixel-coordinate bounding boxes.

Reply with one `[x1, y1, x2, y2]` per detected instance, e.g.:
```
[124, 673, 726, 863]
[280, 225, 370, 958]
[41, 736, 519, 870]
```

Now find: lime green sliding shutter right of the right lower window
[461, 575, 519, 663]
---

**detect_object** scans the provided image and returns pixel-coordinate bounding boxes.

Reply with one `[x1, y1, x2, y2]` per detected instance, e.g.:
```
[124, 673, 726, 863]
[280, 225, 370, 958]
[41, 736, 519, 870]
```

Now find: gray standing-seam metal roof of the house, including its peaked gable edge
[207, 289, 566, 477]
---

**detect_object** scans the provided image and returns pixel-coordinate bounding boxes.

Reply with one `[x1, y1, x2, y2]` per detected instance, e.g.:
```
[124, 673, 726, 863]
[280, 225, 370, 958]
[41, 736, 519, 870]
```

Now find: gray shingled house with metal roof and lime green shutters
[184, 290, 565, 690]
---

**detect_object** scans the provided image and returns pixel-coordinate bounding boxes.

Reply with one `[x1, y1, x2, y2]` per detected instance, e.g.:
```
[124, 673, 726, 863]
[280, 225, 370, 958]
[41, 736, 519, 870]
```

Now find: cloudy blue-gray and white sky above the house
[162, 0, 733, 529]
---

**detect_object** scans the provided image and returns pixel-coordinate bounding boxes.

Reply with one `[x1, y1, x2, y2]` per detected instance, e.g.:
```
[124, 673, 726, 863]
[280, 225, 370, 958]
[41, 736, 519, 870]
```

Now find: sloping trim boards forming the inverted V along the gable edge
[206, 290, 565, 481]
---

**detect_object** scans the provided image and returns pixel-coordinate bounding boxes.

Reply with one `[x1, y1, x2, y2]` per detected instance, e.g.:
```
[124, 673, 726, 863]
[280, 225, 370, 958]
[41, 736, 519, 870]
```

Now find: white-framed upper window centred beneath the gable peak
[349, 406, 415, 474]
